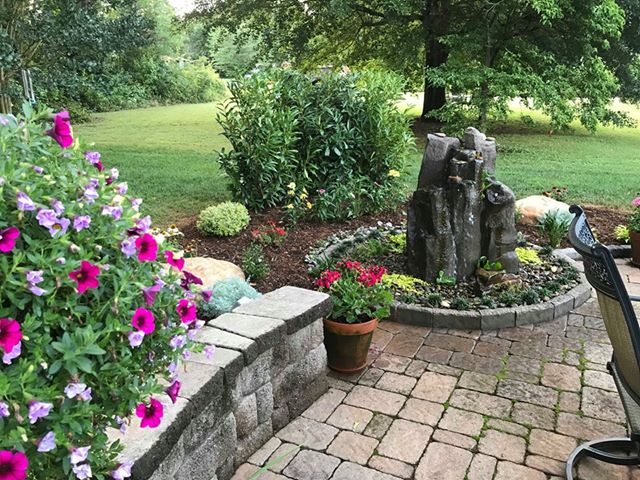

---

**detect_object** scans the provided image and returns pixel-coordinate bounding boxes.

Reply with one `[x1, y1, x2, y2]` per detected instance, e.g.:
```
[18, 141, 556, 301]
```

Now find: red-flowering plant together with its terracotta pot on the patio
[315, 261, 393, 373]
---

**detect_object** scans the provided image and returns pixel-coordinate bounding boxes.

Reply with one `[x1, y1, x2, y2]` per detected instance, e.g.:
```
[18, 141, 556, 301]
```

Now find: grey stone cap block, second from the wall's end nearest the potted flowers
[209, 313, 286, 353]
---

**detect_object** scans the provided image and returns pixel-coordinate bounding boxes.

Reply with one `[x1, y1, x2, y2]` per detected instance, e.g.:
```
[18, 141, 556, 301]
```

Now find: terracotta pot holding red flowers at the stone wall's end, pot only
[324, 318, 378, 373]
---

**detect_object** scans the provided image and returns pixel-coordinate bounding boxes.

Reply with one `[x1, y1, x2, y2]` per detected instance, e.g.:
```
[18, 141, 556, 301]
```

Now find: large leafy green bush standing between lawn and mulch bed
[219, 69, 413, 219]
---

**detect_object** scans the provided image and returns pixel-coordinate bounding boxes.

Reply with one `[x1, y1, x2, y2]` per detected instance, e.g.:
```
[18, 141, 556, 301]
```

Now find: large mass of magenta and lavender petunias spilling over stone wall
[0, 106, 212, 480]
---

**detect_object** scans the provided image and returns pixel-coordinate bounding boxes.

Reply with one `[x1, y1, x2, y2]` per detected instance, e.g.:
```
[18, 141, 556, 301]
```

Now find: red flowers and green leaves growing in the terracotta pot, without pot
[314, 260, 393, 323]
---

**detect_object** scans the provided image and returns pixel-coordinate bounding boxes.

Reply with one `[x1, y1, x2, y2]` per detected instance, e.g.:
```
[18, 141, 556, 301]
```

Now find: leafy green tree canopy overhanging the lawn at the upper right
[191, 0, 640, 129]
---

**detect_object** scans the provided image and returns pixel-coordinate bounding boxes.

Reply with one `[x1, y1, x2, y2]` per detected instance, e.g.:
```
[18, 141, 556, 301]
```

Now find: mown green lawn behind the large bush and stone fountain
[75, 100, 640, 224]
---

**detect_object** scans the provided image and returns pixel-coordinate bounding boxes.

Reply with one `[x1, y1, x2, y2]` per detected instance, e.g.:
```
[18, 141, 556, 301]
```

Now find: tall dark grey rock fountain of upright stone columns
[407, 127, 520, 282]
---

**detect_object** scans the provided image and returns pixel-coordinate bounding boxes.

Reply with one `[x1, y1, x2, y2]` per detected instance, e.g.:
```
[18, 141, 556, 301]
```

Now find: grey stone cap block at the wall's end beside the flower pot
[233, 287, 331, 334]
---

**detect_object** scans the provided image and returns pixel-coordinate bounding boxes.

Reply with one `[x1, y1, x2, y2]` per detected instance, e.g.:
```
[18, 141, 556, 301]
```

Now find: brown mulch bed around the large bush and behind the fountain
[180, 202, 626, 292]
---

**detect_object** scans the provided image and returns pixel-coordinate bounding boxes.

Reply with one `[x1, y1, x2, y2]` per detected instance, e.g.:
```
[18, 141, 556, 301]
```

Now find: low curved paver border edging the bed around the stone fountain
[391, 255, 591, 330]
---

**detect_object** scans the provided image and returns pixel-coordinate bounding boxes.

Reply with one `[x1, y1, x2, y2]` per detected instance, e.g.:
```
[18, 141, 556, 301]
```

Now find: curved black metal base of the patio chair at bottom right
[566, 438, 640, 480]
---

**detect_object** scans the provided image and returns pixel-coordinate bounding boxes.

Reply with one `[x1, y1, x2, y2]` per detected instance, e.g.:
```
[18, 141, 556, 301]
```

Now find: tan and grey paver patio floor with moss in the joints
[234, 261, 640, 480]
